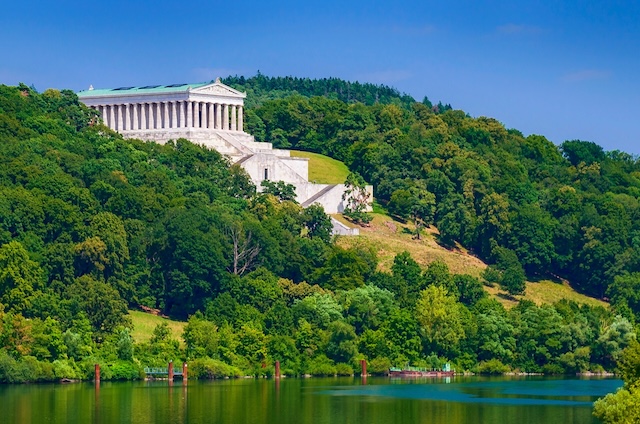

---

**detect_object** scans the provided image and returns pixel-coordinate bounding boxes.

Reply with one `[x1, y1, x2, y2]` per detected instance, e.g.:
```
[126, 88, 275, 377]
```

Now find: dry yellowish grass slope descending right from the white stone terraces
[334, 213, 608, 307]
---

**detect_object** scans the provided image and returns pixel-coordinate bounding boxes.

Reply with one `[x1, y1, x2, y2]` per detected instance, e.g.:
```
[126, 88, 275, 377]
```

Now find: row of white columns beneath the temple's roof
[93, 101, 244, 131]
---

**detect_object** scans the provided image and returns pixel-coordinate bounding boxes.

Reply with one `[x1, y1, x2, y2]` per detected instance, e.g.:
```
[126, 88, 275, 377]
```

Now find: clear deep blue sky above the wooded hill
[0, 0, 640, 154]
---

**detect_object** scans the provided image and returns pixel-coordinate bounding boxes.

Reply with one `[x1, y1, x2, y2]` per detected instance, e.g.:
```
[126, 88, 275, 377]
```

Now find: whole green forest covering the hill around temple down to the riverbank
[0, 78, 640, 382]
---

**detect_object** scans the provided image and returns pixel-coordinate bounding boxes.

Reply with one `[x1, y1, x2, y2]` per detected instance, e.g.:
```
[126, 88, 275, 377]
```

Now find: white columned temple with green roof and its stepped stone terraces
[77, 79, 373, 232]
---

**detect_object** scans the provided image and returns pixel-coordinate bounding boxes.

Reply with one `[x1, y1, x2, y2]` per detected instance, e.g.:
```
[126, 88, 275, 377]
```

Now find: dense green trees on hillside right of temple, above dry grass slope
[238, 78, 640, 319]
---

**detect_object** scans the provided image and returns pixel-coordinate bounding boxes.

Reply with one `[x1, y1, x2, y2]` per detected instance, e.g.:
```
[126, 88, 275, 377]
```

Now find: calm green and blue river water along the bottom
[0, 377, 622, 424]
